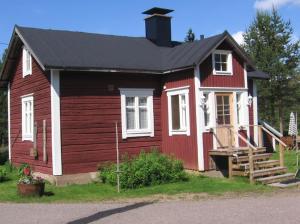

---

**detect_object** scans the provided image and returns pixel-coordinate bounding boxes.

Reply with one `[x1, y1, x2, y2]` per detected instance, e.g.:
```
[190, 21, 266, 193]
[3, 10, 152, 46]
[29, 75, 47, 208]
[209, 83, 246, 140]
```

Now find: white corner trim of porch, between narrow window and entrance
[194, 65, 205, 171]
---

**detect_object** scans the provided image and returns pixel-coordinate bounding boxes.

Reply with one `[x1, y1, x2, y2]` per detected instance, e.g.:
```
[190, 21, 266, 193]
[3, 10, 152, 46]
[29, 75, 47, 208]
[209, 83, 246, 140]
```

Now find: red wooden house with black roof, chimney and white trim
[0, 8, 274, 185]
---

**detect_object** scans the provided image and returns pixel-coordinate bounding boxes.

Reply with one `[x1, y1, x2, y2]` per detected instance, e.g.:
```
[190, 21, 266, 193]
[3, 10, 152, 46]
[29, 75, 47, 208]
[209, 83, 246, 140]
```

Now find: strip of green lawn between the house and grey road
[0, 164, 270, 202]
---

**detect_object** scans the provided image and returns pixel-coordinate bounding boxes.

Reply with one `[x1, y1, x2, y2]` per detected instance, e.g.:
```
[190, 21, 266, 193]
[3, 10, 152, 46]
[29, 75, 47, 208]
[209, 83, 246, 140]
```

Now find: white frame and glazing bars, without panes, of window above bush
[119, 88, 154, 139]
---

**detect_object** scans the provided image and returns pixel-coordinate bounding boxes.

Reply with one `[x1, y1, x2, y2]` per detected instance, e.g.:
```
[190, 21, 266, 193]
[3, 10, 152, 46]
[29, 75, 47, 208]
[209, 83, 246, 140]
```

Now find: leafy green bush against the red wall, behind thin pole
[100, 151, 187, 188]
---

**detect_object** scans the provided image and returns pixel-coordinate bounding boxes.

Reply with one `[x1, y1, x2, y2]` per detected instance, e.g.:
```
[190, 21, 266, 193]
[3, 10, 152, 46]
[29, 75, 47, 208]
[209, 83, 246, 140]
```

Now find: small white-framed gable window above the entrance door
[212, 50, 232, 75]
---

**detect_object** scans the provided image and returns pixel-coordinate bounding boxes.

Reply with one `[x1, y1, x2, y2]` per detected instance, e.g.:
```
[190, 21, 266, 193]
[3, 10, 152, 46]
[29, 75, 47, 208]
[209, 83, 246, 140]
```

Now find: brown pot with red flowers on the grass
[17, 164, 45, 197]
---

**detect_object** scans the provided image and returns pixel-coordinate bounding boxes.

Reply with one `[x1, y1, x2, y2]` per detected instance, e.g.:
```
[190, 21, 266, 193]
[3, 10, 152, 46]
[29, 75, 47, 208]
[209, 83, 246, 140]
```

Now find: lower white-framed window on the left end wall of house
[22, 95, 34, 141]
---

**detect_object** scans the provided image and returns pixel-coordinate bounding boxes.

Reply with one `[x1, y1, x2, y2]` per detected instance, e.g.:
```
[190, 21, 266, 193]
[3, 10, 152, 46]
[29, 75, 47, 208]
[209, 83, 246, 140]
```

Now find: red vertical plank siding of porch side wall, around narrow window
[161, 70, 198, 170]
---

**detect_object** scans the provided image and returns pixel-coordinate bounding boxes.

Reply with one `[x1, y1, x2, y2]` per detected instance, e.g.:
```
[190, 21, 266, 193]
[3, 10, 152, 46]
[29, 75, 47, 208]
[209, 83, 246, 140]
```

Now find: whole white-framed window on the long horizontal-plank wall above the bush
[120, 89, 154, 138]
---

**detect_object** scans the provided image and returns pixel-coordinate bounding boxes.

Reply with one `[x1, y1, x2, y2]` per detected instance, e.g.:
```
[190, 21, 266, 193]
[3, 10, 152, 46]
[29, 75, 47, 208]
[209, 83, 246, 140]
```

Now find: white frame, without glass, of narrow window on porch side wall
[166, 86, 190, 136]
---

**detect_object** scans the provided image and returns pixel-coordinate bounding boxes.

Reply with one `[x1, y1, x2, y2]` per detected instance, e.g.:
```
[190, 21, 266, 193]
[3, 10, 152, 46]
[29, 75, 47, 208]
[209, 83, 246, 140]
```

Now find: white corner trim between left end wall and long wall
[51, 70, 62, 176]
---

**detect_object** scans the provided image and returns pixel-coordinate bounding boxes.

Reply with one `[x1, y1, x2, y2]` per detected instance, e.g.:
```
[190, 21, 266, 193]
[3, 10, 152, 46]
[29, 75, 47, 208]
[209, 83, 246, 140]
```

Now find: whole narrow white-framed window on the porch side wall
[167, 87, 190, 136]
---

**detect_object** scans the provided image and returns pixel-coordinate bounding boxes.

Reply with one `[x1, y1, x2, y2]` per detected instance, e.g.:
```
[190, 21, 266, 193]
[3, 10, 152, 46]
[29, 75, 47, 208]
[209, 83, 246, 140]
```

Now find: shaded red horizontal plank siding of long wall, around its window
[60, 72, 162, 174]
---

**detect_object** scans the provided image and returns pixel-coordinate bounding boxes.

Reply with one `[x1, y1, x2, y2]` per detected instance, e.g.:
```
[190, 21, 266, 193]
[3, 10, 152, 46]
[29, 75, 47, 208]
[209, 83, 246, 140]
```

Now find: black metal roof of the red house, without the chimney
[0, 26, 263, 80]
